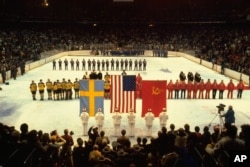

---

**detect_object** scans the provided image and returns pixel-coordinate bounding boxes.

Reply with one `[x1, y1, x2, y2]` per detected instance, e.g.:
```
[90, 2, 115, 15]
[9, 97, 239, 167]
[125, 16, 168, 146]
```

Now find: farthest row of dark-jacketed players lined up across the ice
[52, 58, 147, 71]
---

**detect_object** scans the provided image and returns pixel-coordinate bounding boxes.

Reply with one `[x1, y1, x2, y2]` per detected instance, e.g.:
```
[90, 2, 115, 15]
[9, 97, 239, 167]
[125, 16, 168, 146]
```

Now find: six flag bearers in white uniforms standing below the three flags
[80, 107, 168, 137]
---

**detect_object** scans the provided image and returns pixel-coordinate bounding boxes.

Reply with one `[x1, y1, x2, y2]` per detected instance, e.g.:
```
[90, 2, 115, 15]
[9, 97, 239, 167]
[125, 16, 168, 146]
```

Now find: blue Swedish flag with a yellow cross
[79, 80, 104, 117]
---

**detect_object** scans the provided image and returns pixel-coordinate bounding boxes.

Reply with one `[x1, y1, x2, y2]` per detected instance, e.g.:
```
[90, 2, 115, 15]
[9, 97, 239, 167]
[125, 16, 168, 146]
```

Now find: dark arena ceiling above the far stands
[0, 0, 250, 22]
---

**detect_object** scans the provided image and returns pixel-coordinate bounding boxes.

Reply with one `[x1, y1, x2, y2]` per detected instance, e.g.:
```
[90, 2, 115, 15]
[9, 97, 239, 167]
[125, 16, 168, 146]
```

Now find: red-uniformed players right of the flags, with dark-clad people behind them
[167, 71, 245, 99]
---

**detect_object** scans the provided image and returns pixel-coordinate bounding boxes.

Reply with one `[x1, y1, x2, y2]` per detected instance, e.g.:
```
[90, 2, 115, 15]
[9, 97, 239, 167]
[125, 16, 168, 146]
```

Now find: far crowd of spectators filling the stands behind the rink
[0, 23, 250, 81]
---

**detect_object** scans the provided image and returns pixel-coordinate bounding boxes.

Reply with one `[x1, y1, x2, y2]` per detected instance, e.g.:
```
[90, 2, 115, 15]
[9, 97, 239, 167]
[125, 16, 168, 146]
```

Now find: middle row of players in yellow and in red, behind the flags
[30, 76, 245, 100]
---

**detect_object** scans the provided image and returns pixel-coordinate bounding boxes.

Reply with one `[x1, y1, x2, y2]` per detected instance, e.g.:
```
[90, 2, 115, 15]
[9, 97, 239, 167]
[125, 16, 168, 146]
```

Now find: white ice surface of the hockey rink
[0, 56, 250, 144]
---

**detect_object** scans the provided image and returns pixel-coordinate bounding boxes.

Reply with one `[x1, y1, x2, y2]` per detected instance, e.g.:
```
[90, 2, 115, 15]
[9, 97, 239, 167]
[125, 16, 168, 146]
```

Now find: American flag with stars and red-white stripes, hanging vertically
[110, 75, 136, 113]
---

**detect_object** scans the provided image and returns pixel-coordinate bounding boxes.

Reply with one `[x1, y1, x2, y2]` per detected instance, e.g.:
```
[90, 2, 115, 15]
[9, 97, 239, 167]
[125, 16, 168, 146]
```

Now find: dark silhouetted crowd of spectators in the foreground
[0, 123, 250, 167]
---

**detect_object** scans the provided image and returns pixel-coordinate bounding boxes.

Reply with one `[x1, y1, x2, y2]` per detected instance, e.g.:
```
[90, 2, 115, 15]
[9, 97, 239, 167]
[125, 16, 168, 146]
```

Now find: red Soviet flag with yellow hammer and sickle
[142, 80, 167, 117]
